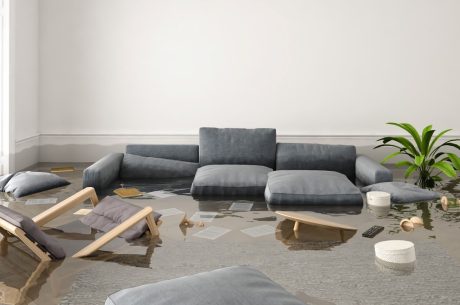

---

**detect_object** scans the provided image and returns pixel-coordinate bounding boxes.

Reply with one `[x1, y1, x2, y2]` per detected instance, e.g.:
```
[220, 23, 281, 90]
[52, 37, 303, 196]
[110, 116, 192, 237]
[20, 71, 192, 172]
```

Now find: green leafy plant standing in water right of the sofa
[374, 122, 460, 188]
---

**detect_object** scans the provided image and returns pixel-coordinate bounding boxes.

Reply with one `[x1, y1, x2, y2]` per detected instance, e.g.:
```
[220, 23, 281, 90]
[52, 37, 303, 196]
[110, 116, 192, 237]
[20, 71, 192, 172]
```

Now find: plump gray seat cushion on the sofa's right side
[265, 170, 363, 205]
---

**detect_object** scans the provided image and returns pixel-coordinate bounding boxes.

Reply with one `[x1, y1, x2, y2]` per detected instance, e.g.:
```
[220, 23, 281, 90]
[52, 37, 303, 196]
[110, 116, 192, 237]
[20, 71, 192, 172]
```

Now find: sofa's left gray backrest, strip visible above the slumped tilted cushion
[126, 145, 198, 163]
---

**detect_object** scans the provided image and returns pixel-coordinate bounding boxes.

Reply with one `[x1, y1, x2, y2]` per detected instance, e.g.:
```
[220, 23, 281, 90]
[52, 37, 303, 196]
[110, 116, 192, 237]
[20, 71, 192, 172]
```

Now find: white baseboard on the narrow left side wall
[14, 135, 40, 171]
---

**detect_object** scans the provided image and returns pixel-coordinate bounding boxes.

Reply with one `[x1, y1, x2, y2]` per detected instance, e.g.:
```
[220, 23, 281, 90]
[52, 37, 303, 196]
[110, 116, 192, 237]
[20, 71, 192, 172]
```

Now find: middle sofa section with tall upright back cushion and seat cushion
[191, 127, 276, 196]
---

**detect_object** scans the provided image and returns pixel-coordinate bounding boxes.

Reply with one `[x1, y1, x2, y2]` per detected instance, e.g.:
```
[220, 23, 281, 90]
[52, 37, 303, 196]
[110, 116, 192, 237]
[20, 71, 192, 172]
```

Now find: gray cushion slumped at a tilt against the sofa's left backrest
[120, 154, 198, 179]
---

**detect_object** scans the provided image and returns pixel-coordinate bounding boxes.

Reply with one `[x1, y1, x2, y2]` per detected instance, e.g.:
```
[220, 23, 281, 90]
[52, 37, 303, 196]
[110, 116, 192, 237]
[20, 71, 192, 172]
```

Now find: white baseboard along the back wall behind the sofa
[39, 134, 455, 162]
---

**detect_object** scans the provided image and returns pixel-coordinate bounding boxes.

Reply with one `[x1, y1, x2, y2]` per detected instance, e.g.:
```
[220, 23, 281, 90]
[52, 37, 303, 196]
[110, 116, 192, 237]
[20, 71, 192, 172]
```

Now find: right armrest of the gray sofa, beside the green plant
[356, 155, 393, 185]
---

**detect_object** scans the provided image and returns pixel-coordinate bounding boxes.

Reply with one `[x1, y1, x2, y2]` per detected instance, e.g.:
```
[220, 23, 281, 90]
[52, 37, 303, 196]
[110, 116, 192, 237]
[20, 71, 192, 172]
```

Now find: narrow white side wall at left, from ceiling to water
[10, 0, 39, 169]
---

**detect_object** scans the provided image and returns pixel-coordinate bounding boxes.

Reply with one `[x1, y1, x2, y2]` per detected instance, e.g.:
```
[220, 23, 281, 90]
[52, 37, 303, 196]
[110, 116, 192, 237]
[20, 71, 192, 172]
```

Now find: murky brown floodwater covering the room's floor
[0, 164, 460, 305]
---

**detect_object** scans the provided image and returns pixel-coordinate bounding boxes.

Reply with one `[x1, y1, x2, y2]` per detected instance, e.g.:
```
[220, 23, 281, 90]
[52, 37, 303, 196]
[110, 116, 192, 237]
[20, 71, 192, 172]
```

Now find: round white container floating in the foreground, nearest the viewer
[374, 240, 415, 264]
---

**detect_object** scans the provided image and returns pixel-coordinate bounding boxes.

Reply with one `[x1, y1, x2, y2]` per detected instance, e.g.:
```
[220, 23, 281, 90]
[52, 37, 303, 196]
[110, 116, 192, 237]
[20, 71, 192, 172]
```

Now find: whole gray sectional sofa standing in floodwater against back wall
[83, 127, 392, 205]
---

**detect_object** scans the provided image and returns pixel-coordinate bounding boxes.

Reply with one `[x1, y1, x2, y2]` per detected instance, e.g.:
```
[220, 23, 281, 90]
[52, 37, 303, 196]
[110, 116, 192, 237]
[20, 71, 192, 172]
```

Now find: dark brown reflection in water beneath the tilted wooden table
[275, 219, 356, 251]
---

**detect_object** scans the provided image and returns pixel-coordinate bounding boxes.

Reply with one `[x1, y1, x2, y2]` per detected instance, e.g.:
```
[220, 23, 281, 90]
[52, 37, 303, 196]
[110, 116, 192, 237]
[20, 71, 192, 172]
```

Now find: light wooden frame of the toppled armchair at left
[0, 187, 159, 261]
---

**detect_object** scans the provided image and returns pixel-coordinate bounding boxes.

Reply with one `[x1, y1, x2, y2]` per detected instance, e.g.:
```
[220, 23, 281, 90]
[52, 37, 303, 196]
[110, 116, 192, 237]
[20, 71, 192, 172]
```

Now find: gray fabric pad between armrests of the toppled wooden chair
[80, 196, 161, 240]
